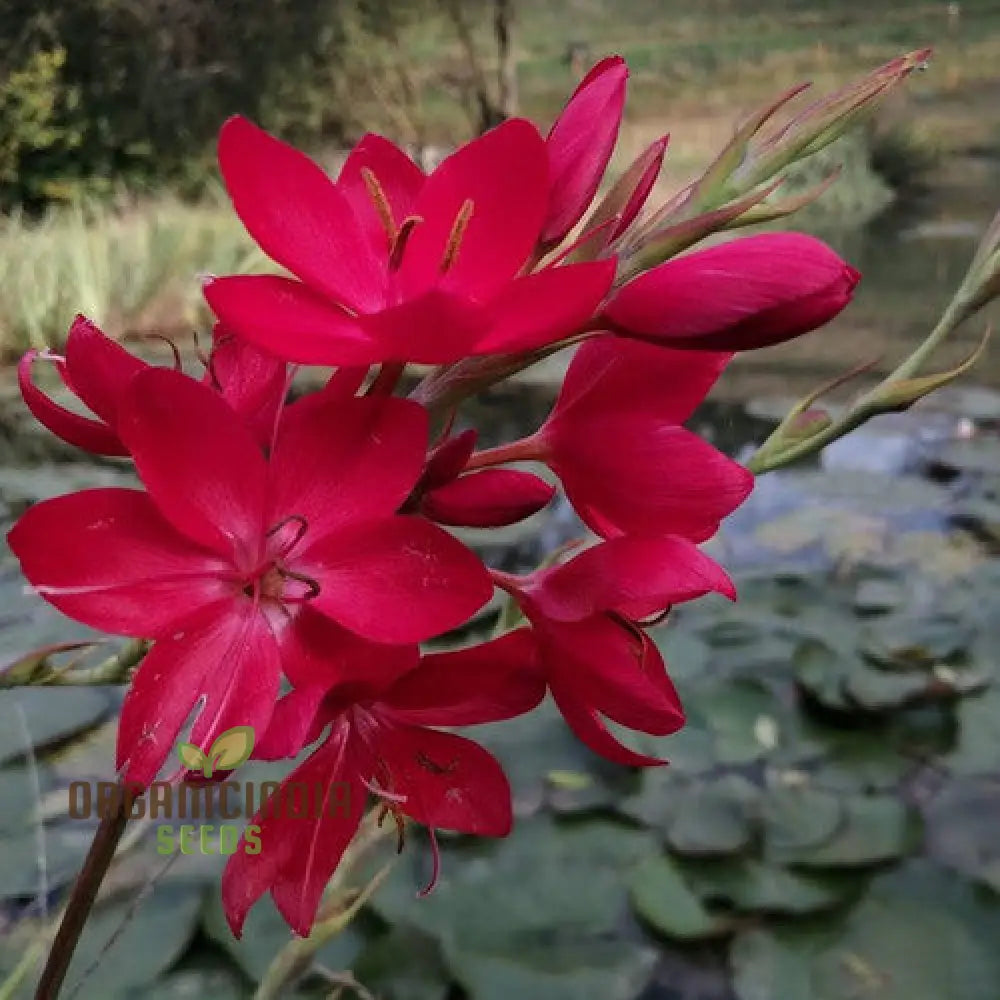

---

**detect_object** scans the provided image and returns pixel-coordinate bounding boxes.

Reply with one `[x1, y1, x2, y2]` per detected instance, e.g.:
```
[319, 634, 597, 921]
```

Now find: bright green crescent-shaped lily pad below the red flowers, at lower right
[629, 855, 731, 941]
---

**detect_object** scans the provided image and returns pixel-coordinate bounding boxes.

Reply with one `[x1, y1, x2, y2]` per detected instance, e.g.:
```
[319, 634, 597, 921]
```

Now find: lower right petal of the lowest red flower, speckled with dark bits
[372, 725, 512, 837]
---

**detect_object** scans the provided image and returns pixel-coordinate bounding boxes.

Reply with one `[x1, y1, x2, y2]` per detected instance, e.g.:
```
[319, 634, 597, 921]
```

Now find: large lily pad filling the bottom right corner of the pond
[730, 863, 1000, 1000]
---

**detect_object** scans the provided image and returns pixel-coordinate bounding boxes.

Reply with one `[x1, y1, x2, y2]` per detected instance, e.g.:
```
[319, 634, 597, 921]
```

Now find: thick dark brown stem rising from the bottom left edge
[35, 785, 132, 1000]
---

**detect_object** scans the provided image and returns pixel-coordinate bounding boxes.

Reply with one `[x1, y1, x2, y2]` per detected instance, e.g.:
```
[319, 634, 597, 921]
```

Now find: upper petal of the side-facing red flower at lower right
[525, 535, 736, 622]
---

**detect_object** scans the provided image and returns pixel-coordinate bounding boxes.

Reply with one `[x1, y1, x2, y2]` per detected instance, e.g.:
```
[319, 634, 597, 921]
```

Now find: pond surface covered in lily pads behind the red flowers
[0, 169, 1000, 1000]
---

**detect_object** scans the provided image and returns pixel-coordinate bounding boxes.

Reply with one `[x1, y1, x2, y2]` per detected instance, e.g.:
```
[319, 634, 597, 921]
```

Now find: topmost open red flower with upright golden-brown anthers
[205, 117, 615, 365]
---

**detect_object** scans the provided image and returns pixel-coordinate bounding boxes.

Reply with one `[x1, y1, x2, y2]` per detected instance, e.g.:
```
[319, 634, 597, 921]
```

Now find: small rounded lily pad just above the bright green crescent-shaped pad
[666, 775, 759, 856]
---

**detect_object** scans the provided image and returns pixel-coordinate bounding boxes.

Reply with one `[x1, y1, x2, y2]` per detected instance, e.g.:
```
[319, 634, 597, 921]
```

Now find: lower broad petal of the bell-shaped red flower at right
[545, 414, 753, 541]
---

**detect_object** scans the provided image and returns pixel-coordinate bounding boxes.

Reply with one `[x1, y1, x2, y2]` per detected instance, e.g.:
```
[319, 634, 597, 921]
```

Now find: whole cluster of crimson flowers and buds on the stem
[9, 58, 858, 934]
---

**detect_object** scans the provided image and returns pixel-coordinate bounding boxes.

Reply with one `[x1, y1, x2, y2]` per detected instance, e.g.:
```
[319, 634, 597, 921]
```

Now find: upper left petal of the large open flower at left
[119, 368, 267, 562]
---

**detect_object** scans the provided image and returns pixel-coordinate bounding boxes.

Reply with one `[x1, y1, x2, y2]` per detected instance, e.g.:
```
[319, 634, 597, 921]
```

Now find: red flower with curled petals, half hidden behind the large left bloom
[17, 316, 287, 455]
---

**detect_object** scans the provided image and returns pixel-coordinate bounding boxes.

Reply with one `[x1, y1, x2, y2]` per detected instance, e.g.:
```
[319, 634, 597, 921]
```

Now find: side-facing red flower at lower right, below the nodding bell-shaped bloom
[493, 535, 736, 766]
